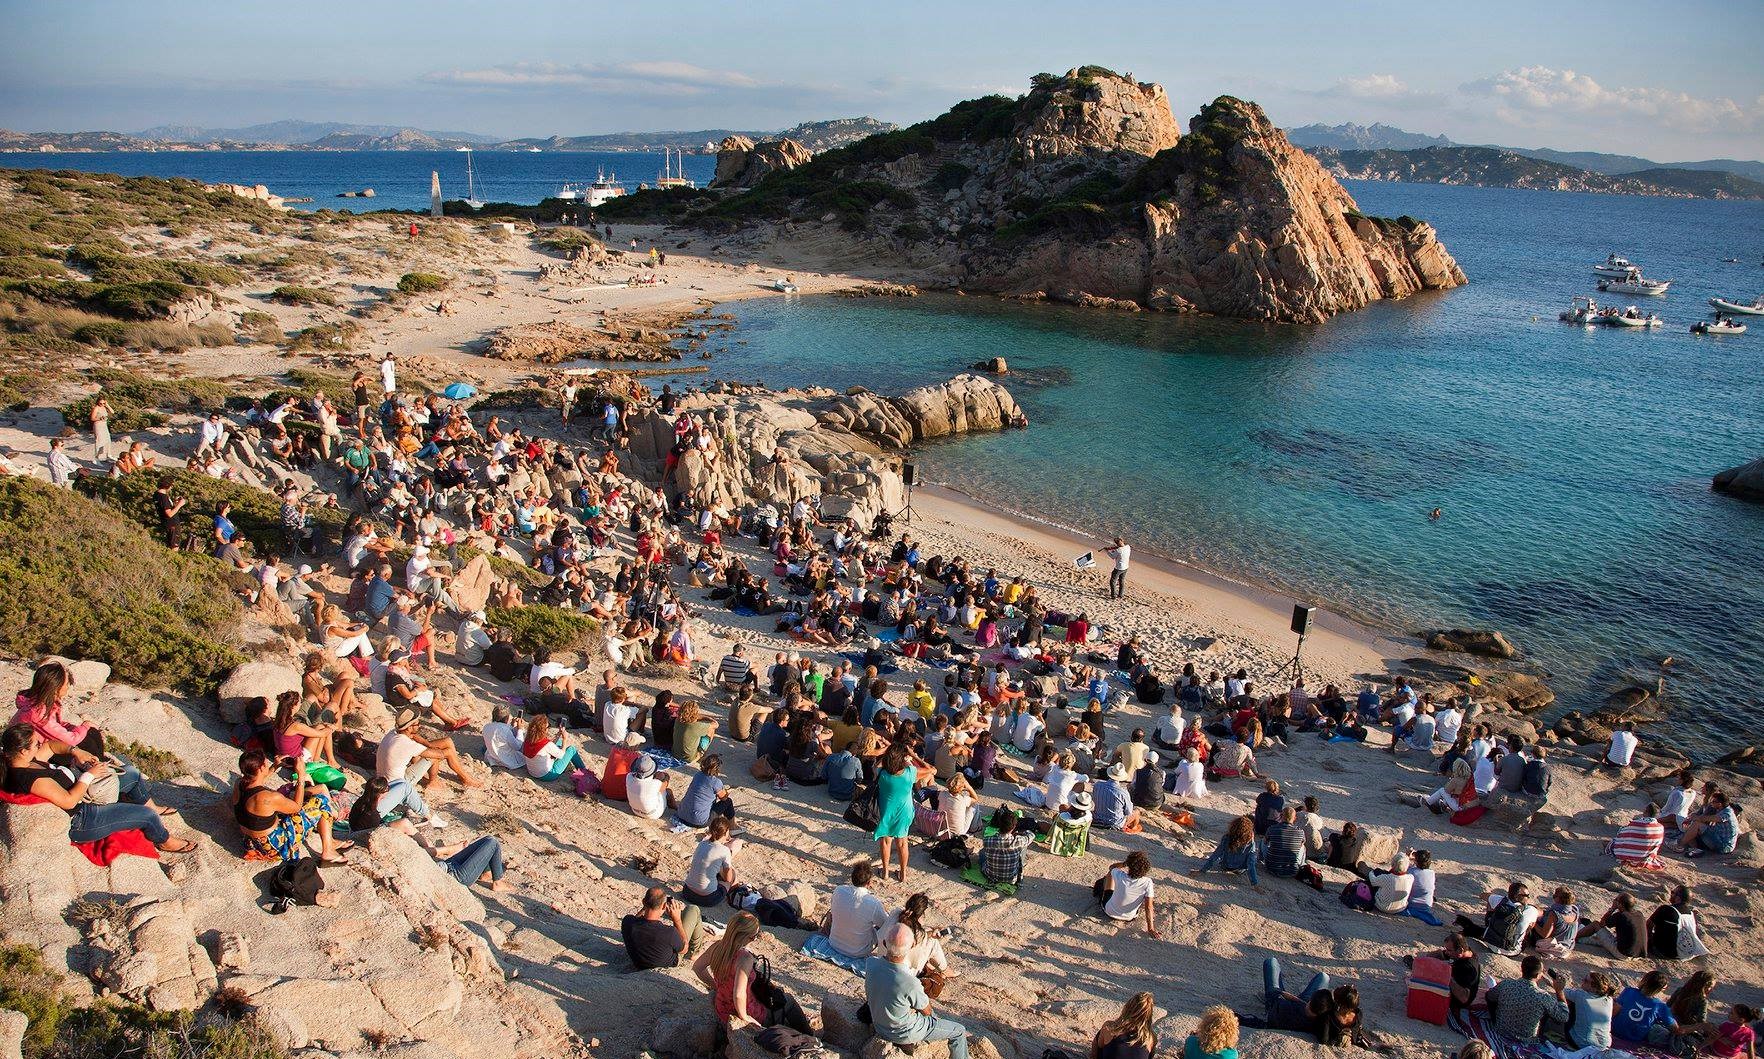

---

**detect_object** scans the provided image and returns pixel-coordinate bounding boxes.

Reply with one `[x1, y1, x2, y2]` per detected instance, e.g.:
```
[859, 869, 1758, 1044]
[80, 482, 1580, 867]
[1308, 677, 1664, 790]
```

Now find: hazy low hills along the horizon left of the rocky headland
[0, 118, 894, 154]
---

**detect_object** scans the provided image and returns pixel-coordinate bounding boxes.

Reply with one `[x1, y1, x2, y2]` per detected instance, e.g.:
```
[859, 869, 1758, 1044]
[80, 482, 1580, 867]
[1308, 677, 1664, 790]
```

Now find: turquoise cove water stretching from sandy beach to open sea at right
[695, 184, 1764, 747]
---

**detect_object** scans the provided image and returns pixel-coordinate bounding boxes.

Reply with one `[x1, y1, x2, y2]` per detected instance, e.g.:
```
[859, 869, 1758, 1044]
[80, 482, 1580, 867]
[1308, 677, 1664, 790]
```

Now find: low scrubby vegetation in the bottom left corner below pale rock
[0, 944, 288, 1059]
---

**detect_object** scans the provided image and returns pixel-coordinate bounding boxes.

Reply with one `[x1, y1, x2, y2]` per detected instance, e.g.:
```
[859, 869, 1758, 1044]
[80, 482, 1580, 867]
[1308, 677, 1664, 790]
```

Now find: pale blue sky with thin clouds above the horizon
[0, 0, 1764, 161]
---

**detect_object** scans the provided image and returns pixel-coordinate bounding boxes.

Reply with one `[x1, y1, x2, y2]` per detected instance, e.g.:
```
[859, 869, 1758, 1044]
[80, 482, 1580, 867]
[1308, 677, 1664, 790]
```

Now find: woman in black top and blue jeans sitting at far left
[0, 724, 196, 852]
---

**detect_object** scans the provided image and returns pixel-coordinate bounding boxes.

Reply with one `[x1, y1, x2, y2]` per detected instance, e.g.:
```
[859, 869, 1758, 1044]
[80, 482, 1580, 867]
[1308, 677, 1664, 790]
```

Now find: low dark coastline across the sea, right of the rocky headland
[1305, 145, 1764, 199]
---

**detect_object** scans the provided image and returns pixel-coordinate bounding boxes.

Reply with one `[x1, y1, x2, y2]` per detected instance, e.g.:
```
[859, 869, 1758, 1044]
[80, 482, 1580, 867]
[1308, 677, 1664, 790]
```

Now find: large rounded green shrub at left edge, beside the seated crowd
[0, 475, 243, 691]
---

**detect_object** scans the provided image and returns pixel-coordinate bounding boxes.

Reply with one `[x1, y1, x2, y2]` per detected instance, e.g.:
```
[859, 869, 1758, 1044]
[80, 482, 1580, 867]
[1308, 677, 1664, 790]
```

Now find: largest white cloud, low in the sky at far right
[1462, 67, 1764, 131]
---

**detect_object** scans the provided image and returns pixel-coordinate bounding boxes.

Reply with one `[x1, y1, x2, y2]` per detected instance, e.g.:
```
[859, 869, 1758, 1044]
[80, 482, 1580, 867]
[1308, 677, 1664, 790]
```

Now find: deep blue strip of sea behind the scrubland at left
[0, 150, 716, 212]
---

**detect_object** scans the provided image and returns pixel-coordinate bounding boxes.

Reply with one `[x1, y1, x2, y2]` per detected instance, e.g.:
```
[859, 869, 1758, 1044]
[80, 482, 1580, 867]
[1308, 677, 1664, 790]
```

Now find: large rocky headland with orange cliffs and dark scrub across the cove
[695, 67, 1466, 323]
